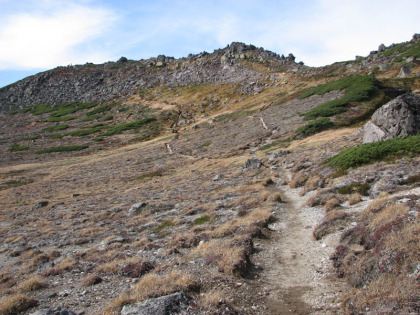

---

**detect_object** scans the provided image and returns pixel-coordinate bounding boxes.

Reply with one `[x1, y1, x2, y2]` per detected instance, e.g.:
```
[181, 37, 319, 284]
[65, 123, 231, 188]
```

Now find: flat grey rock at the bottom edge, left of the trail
[121, 292, 190, 315]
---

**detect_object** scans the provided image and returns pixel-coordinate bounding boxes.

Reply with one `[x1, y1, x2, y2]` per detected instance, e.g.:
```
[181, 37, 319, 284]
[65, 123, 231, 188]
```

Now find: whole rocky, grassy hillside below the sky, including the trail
[0, 35, 420, 314]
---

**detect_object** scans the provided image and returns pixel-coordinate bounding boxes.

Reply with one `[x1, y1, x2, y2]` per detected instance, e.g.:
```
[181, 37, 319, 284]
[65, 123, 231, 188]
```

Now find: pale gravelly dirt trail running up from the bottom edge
[254, 172, 347, 314]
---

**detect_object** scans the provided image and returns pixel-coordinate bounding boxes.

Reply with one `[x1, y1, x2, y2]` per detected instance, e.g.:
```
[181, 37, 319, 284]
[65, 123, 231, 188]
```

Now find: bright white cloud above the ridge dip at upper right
[274, 0, 420, 66]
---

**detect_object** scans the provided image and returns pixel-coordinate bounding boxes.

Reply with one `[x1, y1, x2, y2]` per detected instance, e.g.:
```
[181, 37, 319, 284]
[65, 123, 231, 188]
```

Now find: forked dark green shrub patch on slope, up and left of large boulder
[300, 75, 378, 120]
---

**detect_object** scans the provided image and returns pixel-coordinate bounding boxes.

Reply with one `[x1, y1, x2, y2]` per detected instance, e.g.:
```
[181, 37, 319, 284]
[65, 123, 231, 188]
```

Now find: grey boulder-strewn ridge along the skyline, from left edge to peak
[0, 42, 301, 111]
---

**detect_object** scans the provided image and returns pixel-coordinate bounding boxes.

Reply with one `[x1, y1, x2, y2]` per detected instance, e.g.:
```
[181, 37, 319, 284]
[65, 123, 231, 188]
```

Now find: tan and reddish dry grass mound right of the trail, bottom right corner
[334, 195, 420, 314]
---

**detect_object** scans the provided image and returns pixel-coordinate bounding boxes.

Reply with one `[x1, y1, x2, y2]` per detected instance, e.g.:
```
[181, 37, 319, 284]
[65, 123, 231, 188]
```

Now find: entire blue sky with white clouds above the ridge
[0, 0, 420, 87]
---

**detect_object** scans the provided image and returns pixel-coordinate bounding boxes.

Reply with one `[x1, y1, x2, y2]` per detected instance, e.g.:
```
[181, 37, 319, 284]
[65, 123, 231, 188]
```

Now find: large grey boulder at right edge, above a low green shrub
[363, 93, 420, 143]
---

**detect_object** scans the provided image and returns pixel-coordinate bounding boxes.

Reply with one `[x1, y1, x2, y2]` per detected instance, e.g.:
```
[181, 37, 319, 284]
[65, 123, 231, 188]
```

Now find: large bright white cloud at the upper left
[0, 1, 116, 69]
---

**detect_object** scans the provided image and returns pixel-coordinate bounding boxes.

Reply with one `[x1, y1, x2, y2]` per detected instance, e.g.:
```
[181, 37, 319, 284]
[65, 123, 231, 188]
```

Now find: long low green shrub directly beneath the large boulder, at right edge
[327, 135, 420, 170]
